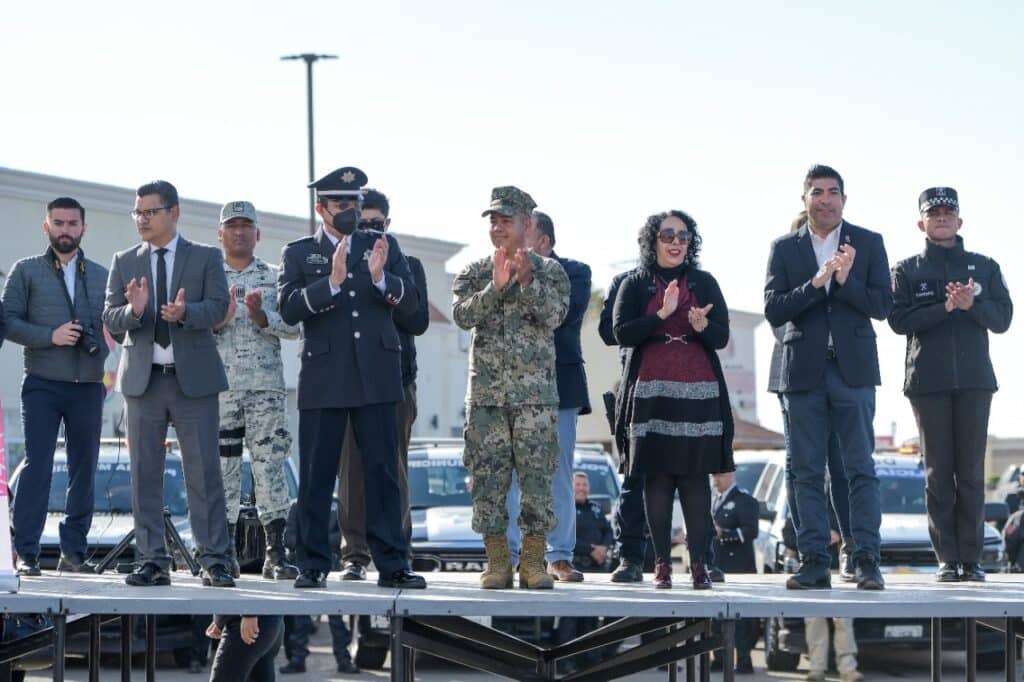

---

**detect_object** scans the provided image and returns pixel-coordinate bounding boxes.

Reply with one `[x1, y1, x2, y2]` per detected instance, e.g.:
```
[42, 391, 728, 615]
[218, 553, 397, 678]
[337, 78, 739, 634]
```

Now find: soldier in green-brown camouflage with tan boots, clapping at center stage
[453, 186, 569, 589]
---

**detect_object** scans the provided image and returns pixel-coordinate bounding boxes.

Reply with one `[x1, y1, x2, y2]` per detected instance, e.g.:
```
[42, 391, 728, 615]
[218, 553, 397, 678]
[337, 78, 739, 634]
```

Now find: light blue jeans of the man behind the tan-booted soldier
[507, 408, 580, 566]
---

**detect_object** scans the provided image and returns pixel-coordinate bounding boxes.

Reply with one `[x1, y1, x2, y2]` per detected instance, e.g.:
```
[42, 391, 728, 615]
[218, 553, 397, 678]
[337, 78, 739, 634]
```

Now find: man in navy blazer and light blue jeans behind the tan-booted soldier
[508, 211, 591, 583]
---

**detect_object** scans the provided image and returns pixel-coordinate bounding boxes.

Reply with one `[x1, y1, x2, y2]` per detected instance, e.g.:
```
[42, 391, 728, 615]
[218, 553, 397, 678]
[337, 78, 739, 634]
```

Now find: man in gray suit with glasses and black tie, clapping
[103, 180, 234, 587]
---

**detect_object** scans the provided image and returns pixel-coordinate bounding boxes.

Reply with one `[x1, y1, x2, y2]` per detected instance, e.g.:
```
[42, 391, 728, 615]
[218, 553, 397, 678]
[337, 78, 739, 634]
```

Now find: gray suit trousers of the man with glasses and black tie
[125, 373, 227, 569]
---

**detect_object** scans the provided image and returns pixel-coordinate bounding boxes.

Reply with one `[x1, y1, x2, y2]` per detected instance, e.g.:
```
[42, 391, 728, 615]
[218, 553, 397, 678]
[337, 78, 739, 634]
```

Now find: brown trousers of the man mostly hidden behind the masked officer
[338, 382, 416, 566]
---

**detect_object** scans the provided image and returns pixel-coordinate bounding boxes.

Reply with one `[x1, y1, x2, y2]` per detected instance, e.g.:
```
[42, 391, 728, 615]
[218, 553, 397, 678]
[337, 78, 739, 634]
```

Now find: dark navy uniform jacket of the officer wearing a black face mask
[278, 226, 419, 410]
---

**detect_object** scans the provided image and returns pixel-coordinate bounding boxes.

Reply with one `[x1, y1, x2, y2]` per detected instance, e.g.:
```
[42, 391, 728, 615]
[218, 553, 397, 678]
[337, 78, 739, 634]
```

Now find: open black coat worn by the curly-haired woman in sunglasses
[612, 267, 736, 471]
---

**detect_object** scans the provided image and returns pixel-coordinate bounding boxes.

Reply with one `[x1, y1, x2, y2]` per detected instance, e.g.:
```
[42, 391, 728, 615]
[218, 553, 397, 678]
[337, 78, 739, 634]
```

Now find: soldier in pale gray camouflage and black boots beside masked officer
[213, 202, 299, 580]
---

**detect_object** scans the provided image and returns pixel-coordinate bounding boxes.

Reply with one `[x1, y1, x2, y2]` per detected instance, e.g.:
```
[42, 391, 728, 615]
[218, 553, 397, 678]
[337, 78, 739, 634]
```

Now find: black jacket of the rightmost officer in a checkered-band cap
[889, 237, 1014, 395]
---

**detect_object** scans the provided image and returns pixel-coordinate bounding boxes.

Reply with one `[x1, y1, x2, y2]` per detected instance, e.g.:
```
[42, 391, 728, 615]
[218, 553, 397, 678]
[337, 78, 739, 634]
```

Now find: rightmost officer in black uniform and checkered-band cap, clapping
[889, 187, 1013, 583]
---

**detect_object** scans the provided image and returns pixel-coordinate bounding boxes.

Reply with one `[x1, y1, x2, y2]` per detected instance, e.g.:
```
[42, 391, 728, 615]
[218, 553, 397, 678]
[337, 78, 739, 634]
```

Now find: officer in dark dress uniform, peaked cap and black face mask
[278, 167, 426, 588]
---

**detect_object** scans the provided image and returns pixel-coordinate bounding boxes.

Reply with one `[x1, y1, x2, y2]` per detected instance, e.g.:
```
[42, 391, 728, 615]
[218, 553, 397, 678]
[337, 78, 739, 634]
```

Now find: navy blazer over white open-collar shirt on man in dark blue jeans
[765, 221, 893, 393]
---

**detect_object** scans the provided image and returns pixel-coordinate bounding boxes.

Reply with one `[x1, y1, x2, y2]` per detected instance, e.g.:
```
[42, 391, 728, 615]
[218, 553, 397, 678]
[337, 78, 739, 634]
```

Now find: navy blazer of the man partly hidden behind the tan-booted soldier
[550, 251, 591, 415]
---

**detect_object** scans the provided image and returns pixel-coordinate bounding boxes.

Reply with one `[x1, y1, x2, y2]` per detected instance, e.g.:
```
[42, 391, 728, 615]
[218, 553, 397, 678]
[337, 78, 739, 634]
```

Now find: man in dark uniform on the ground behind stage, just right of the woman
[711, 471, 759, 674]
